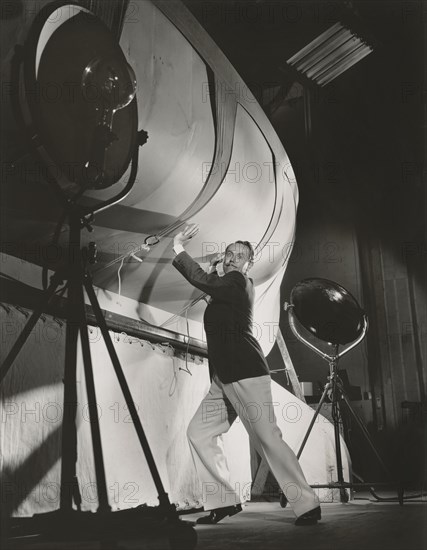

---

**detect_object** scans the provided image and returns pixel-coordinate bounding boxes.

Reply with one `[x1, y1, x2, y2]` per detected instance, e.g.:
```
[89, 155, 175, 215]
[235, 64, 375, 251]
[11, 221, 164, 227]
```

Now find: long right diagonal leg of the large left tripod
[84, 272, 176, 516]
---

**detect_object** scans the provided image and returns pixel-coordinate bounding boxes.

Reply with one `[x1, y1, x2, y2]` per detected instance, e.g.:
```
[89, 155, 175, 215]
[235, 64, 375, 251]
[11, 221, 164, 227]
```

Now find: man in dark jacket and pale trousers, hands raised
[173, 225, 321, 525]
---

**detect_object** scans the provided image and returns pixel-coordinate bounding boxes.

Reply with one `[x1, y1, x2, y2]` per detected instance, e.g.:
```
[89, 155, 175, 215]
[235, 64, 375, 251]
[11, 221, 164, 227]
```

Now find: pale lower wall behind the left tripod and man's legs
[0, 304, 349, 517]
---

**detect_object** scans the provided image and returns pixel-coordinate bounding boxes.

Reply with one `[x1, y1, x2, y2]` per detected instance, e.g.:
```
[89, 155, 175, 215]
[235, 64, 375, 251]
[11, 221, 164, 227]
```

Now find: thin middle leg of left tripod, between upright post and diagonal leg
[79, 280, 111, 512]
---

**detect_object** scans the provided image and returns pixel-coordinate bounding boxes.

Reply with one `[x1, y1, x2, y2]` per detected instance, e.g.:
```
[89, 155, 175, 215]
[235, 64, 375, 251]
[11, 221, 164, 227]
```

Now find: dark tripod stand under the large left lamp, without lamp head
[0, 205, 195, 548]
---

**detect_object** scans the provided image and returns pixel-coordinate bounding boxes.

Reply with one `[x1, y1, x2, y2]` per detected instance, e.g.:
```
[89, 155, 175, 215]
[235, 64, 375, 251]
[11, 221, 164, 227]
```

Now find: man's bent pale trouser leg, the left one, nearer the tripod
[187, 377, 240, 510]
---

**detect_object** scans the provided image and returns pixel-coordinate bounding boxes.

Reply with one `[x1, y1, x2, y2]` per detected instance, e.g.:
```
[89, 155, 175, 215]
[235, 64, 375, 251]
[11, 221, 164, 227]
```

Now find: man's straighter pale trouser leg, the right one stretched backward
[223, 376, 319, 516]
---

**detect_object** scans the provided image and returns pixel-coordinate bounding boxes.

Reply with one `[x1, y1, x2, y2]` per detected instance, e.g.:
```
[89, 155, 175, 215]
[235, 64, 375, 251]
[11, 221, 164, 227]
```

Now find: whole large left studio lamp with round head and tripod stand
[0, 2, 196, 548]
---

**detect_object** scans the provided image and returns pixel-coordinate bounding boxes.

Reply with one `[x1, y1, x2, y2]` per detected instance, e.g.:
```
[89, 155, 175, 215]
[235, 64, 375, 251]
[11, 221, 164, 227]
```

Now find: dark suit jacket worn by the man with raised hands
[173, 252, 269, 383]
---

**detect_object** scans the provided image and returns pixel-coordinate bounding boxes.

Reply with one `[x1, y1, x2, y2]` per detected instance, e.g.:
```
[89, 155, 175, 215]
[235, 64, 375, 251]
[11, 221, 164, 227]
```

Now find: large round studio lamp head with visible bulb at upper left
[20, 4, 138, 195]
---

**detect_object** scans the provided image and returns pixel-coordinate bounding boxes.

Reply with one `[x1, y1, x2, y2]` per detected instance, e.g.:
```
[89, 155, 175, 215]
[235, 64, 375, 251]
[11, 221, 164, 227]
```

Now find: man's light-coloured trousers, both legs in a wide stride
[187, 375, 319, 516]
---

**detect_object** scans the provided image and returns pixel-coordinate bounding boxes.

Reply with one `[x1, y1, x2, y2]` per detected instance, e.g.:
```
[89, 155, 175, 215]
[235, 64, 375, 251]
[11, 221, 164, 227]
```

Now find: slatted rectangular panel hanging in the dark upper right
[286, 22, 373, 86]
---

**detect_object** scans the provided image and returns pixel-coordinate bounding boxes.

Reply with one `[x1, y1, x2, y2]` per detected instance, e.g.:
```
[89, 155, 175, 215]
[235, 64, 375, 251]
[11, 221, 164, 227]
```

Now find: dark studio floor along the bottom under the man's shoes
[4, 495, 427, 550]
